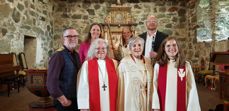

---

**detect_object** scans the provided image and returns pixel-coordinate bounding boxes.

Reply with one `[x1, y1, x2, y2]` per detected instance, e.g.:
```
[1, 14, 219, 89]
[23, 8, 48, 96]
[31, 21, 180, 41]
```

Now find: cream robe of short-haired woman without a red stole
[118, 55, 153, 111]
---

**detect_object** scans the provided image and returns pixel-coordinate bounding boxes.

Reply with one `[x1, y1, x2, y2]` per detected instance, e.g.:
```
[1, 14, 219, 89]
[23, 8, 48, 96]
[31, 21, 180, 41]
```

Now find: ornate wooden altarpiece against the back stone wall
[102, 0, 137, 58]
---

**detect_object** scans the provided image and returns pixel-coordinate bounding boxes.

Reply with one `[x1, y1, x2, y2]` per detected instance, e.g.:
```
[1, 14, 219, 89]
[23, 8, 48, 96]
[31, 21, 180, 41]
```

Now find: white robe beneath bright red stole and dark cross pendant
[77, 59, 110, 111]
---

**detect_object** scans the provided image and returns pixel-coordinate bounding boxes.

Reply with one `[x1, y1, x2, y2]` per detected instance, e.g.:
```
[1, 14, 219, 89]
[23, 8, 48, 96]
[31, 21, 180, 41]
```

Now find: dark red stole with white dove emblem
[158, 64, 187, 111]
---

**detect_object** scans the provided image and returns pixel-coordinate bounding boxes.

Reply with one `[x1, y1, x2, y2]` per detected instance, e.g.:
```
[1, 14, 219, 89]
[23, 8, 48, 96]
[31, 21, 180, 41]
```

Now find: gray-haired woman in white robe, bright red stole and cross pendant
[77, 38, 118, 111]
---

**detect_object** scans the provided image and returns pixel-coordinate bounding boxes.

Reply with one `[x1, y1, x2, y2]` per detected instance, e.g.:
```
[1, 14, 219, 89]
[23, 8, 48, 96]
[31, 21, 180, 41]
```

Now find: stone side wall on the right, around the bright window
[184, 0, 215, 68]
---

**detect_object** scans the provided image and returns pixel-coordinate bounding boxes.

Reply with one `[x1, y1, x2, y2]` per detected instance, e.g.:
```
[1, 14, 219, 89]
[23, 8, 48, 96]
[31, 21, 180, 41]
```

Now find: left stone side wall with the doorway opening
[0, 0, 53, 66]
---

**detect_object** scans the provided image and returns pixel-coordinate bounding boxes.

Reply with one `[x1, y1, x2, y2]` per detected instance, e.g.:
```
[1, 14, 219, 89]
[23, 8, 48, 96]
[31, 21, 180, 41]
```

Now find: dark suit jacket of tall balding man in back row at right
[139, 31, 168, 55]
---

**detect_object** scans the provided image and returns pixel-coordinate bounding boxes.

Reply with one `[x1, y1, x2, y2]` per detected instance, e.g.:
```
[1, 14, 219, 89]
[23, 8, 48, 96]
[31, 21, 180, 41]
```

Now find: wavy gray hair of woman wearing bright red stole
[87, 38, 108, 60]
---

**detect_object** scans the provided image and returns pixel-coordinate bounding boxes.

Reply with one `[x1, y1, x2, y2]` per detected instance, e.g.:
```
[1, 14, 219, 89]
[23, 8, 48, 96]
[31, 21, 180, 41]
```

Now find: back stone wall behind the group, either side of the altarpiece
[54, 0, 188, 53]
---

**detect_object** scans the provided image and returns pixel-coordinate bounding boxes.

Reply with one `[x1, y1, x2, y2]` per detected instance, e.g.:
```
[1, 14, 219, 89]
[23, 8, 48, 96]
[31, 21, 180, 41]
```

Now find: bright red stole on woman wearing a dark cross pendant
[88, 58, 118, 111]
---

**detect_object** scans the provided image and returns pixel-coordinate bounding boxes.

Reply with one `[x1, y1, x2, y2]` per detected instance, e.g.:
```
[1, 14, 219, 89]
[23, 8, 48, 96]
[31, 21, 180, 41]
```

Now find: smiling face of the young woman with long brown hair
[165, 39, 178, 59]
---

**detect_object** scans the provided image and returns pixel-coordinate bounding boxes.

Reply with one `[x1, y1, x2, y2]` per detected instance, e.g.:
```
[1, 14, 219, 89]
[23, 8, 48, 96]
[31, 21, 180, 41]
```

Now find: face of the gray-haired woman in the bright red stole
[95, 41, 107, 59]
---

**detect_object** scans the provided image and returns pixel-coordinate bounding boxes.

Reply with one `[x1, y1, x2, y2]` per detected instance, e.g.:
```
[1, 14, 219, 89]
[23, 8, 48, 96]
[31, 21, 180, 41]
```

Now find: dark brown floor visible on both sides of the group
[0, 85, 223, 111]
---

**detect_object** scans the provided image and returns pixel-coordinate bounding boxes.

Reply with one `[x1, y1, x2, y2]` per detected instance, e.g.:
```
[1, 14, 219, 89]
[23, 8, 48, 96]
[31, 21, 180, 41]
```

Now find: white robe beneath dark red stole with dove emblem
[152, 61, 200, 111]
